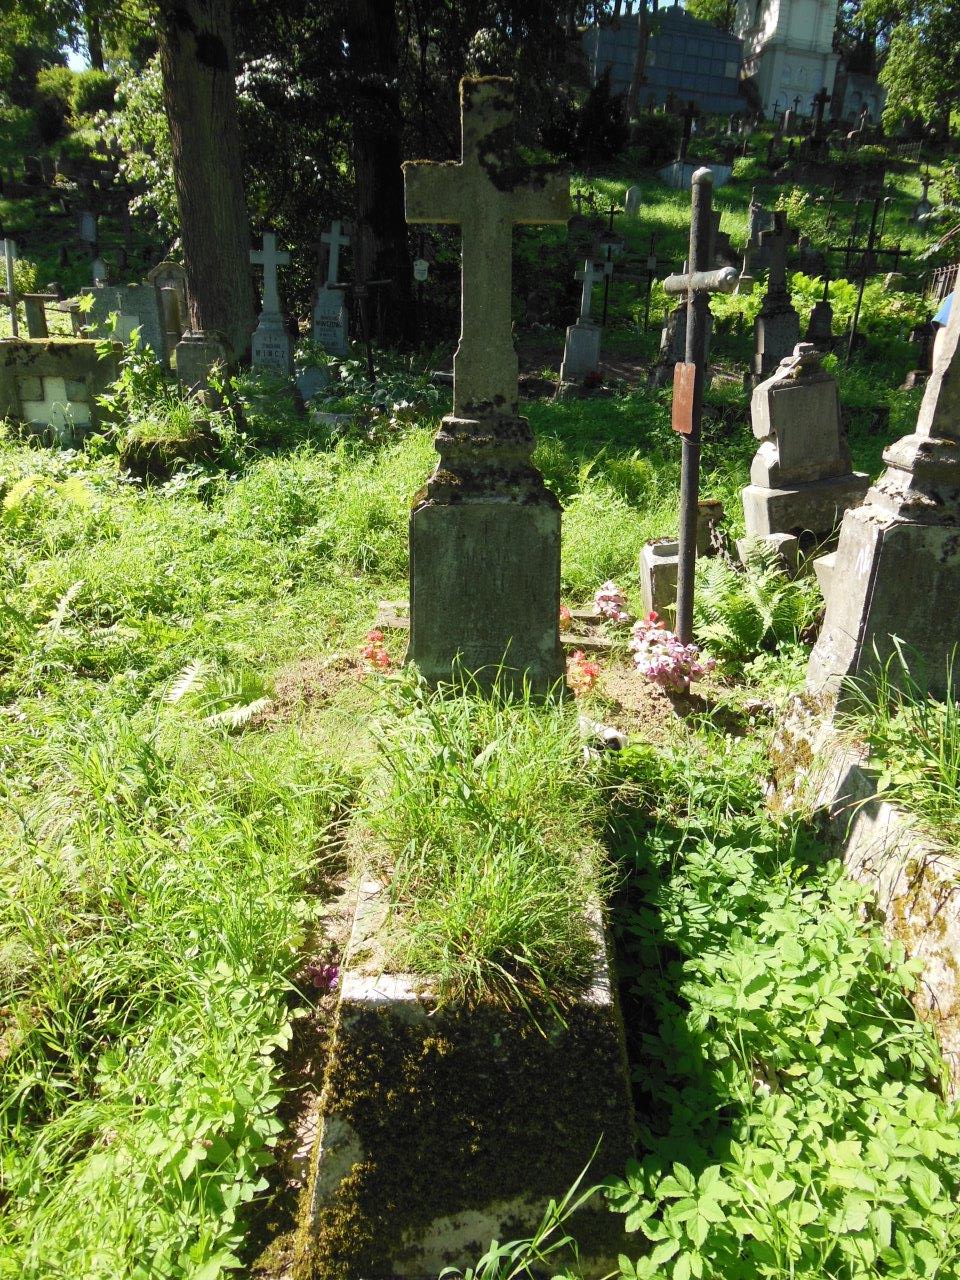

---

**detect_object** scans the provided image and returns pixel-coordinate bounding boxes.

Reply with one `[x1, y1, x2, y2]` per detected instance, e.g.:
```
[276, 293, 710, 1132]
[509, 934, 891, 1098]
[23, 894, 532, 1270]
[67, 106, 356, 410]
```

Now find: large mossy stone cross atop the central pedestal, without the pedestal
[403, 76, 570, 419]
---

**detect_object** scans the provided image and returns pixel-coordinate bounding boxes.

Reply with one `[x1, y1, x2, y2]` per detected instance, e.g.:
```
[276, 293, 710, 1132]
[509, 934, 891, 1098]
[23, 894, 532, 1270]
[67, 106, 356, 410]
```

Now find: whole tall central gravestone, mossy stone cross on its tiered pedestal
[403, 77, 571, 692]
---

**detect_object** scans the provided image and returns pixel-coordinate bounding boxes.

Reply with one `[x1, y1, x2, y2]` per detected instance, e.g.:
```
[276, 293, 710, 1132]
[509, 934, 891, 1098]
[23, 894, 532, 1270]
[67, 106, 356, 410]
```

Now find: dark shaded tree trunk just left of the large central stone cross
[344, 0, 416, 342]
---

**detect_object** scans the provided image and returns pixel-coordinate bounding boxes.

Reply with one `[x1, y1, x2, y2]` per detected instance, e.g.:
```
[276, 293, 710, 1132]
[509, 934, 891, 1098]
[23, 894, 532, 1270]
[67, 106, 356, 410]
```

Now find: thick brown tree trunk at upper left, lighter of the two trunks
[157, 0, 255, 356]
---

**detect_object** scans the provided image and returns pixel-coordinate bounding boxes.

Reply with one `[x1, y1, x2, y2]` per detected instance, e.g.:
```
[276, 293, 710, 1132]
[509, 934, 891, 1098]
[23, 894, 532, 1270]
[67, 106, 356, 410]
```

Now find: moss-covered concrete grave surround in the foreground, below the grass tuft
[293, 881, 634, 1280]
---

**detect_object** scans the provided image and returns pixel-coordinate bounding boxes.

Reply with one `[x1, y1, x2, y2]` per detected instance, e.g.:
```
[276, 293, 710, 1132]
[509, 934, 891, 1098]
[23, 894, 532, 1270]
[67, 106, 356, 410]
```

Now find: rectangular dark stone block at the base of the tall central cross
[407, 489, 566, 695]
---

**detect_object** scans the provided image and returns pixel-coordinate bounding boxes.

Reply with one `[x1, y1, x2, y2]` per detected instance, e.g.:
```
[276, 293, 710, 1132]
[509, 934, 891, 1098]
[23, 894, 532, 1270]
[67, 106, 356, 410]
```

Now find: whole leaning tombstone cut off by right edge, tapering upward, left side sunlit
[806, 288, 960, 698]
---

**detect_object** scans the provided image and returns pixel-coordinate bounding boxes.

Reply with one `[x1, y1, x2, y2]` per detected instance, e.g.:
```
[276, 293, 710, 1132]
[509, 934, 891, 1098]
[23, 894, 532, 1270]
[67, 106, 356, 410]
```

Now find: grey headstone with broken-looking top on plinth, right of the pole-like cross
[742, 343, 869, 543]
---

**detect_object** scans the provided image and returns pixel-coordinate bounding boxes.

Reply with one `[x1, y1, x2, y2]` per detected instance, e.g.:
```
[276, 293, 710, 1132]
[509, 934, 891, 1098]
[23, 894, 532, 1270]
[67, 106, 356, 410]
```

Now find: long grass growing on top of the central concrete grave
[364, 686, 607, 1002]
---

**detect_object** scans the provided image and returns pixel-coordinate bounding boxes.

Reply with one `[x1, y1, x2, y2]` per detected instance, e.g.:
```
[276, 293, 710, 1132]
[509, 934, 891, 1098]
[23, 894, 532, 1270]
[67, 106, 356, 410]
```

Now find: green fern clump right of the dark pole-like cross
[694, 539, 820, 664]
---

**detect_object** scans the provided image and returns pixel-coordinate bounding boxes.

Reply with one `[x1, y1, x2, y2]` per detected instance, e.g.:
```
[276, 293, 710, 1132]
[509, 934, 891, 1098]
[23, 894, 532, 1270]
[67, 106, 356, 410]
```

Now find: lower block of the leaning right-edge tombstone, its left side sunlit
[806, 502, 960, 698]
